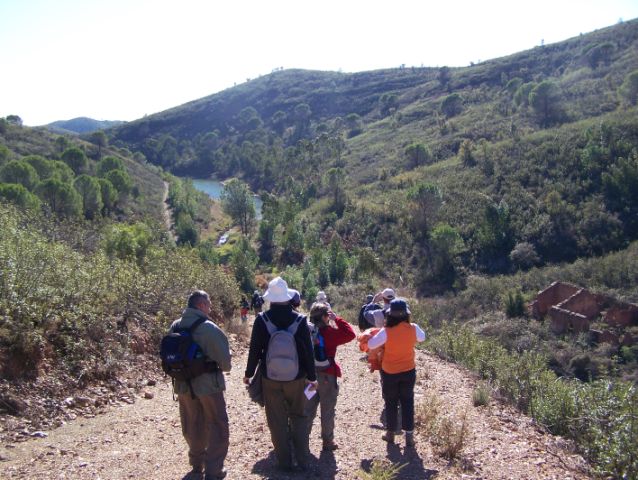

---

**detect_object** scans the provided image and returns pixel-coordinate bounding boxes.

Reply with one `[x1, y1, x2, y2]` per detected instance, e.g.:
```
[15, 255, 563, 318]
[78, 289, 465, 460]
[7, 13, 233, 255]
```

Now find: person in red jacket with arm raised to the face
[306, 303, 356, 451]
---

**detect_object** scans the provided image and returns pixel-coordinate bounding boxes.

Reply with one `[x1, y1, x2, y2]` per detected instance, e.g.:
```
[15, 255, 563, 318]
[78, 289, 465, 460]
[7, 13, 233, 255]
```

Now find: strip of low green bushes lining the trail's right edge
[428, 325, 638, 478]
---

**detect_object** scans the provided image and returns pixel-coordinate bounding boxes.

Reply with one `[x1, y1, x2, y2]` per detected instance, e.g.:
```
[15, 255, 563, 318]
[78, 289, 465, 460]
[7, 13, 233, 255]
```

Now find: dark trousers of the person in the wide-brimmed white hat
[262, 377, 310, 468]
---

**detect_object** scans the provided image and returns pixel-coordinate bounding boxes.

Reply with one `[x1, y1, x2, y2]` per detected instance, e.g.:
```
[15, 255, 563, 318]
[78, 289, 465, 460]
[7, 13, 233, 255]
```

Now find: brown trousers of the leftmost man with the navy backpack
[178, 392, 229, 475]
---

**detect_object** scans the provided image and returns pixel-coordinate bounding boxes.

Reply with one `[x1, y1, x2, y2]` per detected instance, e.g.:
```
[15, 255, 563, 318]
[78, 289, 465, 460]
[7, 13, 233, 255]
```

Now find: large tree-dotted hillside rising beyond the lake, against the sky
[109, 20, 638, 282]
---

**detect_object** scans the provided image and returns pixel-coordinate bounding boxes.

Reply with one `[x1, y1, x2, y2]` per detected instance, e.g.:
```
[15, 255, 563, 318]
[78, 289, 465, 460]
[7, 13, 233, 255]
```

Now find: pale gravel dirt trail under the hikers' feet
[0, 326, 589, 480]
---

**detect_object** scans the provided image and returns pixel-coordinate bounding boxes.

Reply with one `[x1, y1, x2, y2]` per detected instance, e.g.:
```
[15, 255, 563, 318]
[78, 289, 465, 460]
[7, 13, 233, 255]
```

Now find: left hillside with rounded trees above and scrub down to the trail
[0, 119, 239, 396]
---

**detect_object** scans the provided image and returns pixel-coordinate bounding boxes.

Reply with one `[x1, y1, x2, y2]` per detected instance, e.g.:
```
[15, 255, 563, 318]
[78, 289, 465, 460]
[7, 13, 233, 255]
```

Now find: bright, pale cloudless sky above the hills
[0, 0, 638, 126]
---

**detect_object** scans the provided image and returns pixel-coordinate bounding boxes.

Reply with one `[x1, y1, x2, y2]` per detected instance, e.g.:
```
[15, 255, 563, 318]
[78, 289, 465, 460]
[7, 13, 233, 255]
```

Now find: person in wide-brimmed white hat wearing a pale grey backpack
[244, 277, 317, 472]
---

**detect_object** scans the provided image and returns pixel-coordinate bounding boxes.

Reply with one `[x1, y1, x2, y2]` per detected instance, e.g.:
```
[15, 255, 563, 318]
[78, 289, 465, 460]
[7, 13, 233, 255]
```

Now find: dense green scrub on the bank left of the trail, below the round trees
[0, 203, 239, 381]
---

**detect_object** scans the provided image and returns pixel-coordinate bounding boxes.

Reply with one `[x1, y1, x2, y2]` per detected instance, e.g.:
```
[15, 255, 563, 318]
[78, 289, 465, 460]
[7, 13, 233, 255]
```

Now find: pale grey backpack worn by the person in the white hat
[262, 312, 305, 382]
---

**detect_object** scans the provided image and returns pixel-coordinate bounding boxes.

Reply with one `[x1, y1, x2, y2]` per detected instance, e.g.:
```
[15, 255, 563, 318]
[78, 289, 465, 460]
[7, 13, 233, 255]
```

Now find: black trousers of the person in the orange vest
[381, 369, 416, 432]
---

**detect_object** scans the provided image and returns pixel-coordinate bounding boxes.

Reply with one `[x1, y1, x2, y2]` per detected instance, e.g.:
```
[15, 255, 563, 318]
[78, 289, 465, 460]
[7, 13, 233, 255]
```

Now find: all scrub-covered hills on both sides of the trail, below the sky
[0, 20, 638, 478]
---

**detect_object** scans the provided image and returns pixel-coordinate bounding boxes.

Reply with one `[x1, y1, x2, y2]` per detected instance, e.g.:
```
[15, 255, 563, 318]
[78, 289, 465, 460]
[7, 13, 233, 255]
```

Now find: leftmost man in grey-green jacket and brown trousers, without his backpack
[170, 290, 230, 480]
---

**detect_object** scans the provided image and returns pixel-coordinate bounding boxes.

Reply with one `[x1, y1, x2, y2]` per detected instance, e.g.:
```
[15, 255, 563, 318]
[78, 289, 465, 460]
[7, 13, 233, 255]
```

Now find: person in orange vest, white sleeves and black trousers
[368, 298, 425, 447]
